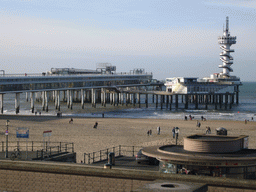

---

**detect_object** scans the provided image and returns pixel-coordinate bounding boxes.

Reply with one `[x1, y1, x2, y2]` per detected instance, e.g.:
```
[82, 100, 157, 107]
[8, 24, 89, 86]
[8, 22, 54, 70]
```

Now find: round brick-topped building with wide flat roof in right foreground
[142, 135, 256, 179]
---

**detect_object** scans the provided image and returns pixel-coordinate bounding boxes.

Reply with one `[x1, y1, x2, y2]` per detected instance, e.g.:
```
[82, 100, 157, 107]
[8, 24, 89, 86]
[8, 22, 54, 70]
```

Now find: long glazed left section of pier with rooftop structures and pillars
[0, 65, 163, 114]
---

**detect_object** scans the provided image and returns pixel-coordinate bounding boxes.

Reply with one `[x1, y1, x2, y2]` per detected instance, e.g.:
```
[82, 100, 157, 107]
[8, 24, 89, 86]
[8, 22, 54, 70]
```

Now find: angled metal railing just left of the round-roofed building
[84, 145, 142, 164]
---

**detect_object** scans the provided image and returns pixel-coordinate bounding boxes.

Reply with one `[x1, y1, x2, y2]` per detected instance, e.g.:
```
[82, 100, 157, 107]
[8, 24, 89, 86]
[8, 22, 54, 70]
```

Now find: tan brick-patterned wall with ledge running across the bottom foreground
[0, 161, 256, 192]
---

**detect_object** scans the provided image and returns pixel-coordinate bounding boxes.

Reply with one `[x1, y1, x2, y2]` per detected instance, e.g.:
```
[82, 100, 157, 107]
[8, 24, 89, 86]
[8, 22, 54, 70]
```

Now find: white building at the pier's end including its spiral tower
[165, 17, 242, 109]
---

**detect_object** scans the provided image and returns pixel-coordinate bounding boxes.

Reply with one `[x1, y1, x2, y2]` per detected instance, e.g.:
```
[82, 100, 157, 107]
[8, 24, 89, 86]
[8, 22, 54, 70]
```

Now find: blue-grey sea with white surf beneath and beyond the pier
[3, 82, 256, 121]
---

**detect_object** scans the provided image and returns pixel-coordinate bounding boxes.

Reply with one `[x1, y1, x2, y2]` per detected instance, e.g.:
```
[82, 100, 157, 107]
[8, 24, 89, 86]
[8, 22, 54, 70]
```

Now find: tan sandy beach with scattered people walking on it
[0, 115, 256, 162]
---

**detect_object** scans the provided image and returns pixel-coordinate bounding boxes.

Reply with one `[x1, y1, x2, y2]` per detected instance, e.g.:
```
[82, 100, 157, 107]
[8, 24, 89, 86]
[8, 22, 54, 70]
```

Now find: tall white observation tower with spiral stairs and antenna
[218, 17, 236, 77]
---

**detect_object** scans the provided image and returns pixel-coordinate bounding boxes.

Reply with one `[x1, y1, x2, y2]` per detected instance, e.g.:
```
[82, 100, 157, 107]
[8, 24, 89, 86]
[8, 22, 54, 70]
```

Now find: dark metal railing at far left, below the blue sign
[0, 141, 74, 152]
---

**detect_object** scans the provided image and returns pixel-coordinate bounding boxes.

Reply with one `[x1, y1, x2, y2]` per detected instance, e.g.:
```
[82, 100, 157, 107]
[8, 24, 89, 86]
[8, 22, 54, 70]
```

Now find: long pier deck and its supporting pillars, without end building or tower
[0, 73, 239, 114]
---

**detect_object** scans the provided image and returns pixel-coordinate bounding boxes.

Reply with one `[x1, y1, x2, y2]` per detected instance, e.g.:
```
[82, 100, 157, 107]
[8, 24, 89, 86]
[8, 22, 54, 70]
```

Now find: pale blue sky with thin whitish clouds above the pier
[0, 0, 256, 81]
